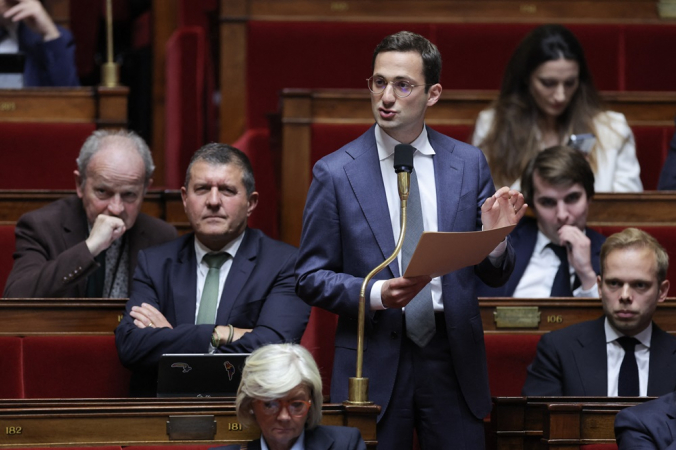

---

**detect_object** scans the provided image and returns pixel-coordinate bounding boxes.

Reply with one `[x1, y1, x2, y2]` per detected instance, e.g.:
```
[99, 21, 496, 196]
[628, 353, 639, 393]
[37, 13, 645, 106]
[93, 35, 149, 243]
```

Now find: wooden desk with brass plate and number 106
[479, 297, 676, 334]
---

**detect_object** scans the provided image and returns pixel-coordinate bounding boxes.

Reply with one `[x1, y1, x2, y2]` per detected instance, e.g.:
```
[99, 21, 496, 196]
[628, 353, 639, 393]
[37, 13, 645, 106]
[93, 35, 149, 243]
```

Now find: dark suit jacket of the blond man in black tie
[522, 317, 676, 397]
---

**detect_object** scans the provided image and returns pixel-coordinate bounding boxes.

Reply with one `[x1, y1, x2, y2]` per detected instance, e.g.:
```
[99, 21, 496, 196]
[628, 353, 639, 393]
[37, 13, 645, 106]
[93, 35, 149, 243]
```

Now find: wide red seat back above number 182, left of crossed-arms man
[23, 335, 130, 398]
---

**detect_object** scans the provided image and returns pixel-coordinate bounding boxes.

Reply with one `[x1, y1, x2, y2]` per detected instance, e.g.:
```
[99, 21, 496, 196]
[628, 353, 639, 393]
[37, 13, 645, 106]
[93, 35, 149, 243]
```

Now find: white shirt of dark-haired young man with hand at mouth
[512, 231, 598, 298]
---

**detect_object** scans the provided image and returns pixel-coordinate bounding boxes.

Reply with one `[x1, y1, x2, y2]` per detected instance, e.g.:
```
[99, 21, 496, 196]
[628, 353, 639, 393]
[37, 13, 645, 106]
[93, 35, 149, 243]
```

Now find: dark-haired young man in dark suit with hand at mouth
[478, 146, 606, 298]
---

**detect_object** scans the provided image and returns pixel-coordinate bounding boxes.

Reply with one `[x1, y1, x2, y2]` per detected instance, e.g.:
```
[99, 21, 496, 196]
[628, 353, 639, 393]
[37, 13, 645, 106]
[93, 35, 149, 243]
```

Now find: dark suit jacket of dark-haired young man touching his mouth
[477, 217, 606, 297]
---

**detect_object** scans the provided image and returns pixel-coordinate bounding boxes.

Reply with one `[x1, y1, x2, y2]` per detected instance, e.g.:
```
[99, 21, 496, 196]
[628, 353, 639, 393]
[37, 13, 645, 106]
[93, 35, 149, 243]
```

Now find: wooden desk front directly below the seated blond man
[490, 397, 653, 450]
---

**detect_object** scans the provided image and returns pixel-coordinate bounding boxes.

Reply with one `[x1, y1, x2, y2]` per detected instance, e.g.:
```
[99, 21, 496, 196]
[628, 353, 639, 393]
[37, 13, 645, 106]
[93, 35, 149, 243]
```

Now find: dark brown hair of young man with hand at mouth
[521, 145, 594, 205]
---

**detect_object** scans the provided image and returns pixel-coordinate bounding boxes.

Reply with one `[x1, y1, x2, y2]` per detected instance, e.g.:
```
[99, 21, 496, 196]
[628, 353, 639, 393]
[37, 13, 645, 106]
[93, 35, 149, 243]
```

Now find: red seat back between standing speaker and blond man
[484, 334, 540, 397]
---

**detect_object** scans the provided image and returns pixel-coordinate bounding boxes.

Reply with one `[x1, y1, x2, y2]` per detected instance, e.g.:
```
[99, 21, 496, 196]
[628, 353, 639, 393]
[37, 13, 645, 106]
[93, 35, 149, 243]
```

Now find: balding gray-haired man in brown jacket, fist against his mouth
[3, 130, 176, 298]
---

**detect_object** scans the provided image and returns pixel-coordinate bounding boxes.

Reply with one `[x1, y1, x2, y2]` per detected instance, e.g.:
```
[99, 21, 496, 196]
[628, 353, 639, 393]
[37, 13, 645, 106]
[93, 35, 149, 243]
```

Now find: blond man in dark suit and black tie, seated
[522, 228, 676, 397]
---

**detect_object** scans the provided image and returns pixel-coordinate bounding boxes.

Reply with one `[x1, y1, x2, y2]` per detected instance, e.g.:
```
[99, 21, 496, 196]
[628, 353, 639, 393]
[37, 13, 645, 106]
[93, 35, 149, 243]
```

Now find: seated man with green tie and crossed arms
[115, 144, 310, 396]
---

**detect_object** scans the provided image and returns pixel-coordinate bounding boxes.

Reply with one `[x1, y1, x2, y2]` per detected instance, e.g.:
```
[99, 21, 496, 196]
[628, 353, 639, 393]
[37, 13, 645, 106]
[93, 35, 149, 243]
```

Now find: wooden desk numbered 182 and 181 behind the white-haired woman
[0, 398, 380, 448]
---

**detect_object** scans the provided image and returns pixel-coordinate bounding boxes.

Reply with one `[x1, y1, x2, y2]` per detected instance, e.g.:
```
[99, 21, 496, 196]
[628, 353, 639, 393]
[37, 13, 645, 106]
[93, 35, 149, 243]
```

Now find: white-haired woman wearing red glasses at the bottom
[211, 344, 366, 450]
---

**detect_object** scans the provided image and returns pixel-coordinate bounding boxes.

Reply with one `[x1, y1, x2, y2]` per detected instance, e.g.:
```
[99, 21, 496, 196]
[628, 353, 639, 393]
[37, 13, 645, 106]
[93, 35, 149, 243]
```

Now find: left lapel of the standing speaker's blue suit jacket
[344, 128, 400, 277]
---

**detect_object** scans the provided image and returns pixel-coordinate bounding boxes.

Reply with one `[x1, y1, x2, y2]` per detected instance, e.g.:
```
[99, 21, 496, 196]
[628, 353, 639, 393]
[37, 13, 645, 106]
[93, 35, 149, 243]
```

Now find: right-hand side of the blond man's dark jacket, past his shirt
[648, 323, 676, 396]
